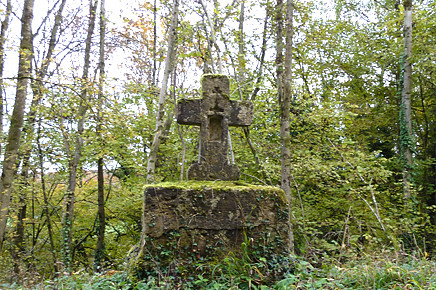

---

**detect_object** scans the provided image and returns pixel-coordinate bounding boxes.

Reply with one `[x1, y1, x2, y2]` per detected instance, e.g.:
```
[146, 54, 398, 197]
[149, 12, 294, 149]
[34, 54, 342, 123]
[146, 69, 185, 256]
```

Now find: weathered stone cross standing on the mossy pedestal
[177, 74, 253, 180]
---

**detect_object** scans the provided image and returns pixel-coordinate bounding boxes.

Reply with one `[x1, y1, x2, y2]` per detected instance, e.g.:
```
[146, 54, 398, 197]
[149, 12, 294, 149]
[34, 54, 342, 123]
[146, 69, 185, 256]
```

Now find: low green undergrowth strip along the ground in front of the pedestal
[0, 248, 436, 289]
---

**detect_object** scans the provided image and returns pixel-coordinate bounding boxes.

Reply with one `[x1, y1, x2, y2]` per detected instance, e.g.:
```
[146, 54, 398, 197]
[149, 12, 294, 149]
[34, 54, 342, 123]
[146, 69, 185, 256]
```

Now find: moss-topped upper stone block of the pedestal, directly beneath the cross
[143, 183, 284, 237]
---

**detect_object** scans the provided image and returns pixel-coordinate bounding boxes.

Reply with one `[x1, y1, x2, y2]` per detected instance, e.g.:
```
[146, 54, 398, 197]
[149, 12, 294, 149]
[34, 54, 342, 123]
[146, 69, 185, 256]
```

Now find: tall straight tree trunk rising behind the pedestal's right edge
[277, 0, 294, 253]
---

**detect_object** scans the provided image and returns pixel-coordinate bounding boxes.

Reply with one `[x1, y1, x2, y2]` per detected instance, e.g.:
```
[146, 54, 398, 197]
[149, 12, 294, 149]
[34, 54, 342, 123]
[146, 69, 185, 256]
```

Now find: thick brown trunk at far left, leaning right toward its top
[0, 0, 33, 250]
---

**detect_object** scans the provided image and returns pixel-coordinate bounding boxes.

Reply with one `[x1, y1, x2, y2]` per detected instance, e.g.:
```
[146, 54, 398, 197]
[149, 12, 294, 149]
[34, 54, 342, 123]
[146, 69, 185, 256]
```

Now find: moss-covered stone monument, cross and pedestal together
[129, 75, 289, 279]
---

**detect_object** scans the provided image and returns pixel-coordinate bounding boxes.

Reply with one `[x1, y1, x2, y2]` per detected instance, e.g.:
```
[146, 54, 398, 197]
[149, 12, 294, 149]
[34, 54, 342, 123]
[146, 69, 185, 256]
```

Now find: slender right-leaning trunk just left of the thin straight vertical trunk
[62, 0, 98, 272]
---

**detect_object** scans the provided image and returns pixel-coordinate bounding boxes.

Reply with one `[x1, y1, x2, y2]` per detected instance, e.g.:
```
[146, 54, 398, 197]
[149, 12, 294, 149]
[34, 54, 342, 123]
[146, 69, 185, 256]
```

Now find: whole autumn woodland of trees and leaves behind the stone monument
[0, 0, 436, 289]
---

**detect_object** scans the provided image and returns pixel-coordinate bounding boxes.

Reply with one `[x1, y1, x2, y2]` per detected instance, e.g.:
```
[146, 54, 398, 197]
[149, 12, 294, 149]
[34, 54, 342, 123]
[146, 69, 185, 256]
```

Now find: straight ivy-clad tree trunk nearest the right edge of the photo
[400, 0, 414, 199]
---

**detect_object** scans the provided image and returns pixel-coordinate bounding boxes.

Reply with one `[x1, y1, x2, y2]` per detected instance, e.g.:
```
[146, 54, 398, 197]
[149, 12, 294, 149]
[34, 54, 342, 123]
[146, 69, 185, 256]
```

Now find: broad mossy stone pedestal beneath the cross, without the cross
[130, 181, 288, 278]
